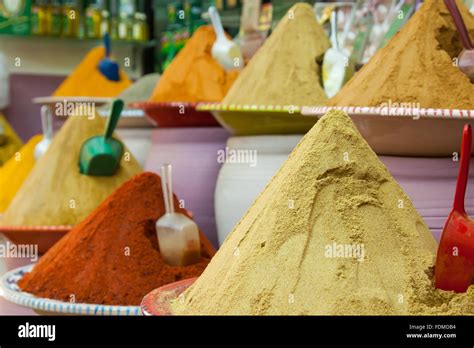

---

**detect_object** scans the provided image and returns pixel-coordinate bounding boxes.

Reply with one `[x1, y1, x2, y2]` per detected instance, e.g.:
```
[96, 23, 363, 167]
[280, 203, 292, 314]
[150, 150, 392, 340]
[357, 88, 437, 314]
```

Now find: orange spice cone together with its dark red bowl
[137, 26, 238, 127]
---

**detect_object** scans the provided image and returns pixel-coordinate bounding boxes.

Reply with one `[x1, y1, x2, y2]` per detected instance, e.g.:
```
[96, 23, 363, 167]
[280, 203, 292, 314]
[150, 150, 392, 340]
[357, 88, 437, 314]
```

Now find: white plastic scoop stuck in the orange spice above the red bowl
[209, 6, 244, 70]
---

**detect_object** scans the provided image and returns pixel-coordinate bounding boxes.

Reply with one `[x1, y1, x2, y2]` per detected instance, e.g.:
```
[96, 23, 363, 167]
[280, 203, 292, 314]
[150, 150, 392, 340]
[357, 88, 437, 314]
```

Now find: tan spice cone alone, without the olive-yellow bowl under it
[223, 3, 331, 106]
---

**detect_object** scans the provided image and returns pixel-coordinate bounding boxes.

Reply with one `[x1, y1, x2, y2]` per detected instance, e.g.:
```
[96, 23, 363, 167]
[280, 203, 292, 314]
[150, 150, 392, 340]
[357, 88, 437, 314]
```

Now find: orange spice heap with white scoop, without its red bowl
[149, 26, 238, 102]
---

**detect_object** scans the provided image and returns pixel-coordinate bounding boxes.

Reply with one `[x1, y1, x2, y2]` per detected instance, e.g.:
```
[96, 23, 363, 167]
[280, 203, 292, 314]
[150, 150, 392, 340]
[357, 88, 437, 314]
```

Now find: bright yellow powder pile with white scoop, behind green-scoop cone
[0, 135, 43, 213]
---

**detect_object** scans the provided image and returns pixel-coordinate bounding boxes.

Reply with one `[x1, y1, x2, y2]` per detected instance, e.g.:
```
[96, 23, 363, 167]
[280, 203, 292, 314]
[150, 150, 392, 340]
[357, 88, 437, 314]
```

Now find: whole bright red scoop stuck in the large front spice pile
[435, 124, 474, 292]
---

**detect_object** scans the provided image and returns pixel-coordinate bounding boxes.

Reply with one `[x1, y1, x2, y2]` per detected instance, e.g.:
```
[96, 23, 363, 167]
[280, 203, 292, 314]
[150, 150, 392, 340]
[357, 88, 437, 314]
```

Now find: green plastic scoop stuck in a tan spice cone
[79, 99, 123, 176]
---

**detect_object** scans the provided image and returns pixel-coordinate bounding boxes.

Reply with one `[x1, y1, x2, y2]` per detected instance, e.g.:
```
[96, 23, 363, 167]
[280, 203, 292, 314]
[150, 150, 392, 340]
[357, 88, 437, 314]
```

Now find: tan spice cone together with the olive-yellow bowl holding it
[206, 3, 330, 135]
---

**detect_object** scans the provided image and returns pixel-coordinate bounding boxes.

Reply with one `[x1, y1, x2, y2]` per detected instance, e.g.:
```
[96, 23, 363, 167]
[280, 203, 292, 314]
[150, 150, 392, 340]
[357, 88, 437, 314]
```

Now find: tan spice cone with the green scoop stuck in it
[0, 114, 142, 226]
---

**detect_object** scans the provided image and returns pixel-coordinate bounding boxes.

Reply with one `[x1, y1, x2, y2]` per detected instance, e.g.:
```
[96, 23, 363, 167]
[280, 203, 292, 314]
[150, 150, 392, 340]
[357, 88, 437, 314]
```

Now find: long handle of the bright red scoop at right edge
[453, 124, 472, 214]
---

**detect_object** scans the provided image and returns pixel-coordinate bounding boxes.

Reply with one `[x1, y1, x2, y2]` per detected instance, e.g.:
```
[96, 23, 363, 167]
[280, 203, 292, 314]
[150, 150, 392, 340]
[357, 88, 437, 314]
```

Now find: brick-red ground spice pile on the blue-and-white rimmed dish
[19, 173, 214, 305]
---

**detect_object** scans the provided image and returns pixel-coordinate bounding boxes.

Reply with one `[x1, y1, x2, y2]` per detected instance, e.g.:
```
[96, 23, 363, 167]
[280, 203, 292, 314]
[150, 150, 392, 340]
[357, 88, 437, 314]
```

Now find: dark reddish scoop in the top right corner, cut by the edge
[444, 0, 474, 83]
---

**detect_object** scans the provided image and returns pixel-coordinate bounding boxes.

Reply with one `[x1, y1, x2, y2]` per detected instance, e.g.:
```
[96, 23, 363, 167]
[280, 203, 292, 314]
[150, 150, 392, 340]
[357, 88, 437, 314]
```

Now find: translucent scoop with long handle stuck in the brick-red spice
[156, 164, 201, 266]
